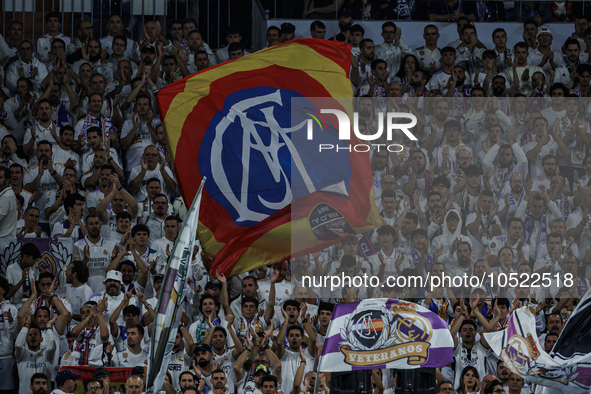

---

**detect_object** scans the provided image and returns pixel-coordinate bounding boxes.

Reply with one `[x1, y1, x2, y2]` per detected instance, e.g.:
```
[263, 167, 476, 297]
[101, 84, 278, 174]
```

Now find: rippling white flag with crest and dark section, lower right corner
[484, 290, 591, 394]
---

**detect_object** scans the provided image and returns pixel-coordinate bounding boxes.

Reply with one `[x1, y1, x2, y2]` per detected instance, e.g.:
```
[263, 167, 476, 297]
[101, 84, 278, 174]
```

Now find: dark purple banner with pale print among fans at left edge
[0, 238, 73, 275]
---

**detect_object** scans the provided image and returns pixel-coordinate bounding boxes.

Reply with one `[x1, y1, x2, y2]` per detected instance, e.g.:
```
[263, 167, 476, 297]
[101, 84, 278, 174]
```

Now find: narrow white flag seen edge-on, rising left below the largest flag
[146, 179, 205, 394]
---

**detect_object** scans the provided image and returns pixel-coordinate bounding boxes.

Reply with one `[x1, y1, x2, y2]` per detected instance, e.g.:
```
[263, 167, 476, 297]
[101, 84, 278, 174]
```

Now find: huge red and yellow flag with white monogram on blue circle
[158, 39, 381, 276]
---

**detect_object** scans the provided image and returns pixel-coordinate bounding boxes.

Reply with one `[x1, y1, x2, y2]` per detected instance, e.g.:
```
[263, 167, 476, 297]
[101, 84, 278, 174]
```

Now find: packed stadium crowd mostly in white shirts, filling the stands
[0, 1, 591, 394]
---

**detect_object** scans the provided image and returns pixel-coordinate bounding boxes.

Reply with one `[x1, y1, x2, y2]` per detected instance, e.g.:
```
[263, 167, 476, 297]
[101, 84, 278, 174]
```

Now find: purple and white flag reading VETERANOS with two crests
[319, 298, 454, 372]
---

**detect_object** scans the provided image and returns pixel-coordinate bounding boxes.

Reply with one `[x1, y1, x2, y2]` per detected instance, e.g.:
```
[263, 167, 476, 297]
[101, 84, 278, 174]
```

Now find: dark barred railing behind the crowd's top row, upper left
[2, 0, 266, 50]
